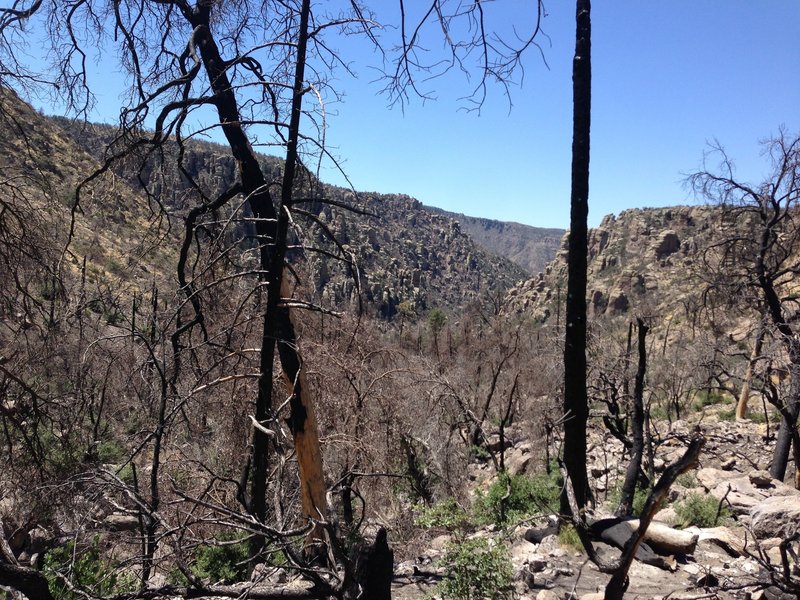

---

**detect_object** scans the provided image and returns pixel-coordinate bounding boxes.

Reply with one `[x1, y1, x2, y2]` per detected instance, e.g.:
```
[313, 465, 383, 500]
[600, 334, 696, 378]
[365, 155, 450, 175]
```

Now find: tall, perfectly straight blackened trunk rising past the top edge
[562, 0, 592, 516]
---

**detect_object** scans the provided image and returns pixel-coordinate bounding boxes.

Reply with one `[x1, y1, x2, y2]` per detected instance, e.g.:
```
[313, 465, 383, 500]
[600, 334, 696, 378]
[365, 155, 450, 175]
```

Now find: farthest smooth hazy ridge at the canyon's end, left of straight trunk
[426, 207, 564, 274]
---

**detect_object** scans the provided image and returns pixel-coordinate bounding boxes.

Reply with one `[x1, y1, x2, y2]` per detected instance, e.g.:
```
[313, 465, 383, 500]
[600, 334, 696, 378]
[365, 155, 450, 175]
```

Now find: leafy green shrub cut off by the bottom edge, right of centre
[437, 538, 514, 600]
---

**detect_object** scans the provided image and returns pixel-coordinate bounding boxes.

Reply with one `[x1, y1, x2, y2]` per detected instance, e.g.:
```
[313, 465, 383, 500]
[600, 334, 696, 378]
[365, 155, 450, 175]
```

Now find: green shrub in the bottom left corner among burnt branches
[44, 536, 137, 600]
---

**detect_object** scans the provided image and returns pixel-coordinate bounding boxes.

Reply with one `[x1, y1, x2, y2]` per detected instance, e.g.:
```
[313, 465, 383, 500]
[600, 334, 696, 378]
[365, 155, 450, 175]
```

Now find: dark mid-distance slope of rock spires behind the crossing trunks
[49, 110, 526, 319]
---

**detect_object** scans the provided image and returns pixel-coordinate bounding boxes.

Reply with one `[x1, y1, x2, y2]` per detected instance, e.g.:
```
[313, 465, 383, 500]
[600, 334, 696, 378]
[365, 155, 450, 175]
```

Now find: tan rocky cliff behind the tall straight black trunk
[506, 206, 720, 321]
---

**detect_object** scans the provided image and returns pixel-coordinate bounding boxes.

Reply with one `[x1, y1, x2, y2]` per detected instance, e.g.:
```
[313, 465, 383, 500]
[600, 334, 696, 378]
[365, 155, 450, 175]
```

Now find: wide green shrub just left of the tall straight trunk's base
[475, 472, 561, 526]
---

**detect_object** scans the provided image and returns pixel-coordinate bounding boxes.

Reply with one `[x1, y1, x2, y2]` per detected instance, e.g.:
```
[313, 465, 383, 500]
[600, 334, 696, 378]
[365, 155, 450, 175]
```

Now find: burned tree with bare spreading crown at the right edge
[689, 132, 800, 483]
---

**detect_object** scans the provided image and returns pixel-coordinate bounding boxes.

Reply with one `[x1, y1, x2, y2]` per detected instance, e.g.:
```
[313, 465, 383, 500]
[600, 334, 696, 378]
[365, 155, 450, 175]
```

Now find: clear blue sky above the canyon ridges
[21, 0, 800, 227]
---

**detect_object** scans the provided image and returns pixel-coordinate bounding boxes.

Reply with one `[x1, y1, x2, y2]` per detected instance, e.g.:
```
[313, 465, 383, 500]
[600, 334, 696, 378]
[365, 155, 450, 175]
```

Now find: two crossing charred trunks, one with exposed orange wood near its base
[187, 0, 326, 542]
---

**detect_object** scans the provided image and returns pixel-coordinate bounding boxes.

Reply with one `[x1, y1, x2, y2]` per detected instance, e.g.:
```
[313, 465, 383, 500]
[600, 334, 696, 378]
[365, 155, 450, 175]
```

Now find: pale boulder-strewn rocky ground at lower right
[393, 415, 800, 600]
